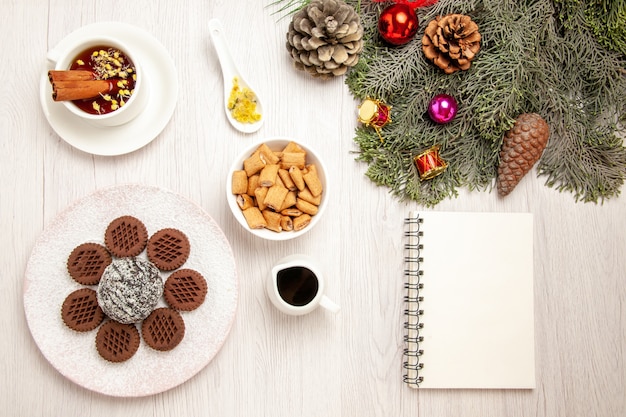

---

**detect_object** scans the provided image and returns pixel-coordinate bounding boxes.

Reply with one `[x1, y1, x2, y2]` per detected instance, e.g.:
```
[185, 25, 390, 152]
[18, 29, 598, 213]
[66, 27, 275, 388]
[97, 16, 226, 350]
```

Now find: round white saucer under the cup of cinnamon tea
[39, 22, 178, 156]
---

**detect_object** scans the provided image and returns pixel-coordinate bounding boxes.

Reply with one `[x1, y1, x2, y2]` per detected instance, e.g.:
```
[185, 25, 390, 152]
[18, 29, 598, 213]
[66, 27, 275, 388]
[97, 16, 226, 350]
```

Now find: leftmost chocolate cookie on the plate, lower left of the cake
[61, 288, 104, 332]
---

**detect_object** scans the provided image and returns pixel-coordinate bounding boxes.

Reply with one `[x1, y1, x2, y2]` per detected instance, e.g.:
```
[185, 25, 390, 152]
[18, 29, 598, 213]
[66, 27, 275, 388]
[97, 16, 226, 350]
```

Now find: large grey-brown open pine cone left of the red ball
[287, 0, 363, 78]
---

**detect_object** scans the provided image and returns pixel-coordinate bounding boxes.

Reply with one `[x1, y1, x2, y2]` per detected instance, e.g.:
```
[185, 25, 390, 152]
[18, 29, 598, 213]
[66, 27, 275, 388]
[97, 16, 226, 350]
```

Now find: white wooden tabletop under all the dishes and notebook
[0, 0, 626, 417]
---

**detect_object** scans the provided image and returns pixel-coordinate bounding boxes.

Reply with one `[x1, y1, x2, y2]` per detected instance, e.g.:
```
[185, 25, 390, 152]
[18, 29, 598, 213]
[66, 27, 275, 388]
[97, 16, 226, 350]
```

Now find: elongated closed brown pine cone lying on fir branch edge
[496, 113, 550, 197]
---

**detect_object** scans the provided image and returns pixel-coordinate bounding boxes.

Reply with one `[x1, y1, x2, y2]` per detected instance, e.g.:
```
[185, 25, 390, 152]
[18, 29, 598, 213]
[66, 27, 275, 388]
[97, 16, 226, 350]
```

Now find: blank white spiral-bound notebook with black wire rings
[403, 211, 535, 389]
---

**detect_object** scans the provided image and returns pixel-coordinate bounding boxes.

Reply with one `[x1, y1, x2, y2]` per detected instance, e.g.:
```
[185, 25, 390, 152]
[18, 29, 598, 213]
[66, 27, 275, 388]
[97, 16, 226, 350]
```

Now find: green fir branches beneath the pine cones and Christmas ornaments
[346, 0, 626, 206]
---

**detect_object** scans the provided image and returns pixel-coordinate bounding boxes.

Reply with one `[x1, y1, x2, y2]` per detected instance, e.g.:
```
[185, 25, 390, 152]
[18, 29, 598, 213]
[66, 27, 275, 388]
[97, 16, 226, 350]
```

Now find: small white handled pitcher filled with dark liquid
[267, 254, 339, 316]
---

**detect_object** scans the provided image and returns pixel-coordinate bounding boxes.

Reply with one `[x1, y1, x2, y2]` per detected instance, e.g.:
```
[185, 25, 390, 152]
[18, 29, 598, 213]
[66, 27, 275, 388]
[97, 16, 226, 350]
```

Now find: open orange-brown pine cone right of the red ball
[422, 14, 480, 74]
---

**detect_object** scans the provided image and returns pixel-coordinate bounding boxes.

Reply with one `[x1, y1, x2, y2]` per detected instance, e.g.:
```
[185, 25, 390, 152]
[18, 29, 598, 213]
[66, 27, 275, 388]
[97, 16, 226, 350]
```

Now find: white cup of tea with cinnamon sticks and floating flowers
[46, 36, 149, 127]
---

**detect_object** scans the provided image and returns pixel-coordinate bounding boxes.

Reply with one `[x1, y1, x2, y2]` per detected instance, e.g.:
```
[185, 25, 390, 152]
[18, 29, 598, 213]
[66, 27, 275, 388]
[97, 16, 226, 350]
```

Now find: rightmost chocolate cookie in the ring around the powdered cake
[163, 269, 207, 311]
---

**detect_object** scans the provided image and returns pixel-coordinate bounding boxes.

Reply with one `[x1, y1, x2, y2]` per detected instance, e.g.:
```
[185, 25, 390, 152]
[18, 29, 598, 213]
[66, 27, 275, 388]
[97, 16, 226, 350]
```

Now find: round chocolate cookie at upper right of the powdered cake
[148, 228, 190, 271]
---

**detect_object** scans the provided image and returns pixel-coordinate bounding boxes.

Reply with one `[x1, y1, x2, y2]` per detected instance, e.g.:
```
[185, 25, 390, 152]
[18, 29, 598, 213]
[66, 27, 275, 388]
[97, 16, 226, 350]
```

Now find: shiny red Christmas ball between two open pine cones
[378, 3, 419, 45]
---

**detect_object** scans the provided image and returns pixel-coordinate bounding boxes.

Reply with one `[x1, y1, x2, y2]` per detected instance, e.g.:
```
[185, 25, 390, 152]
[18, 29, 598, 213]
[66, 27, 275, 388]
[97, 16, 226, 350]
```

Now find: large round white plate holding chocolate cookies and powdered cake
[24, 185, 238, 397]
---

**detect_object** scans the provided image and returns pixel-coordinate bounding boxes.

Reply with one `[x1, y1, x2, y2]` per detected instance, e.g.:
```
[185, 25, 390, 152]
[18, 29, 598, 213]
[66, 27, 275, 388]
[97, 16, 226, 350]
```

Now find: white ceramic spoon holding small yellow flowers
[209, 19, 265, 133]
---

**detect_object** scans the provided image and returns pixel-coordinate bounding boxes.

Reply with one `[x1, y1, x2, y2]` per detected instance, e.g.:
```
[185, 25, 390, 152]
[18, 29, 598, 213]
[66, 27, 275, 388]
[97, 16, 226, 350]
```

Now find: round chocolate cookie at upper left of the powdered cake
[67, 243, 111, 285]
